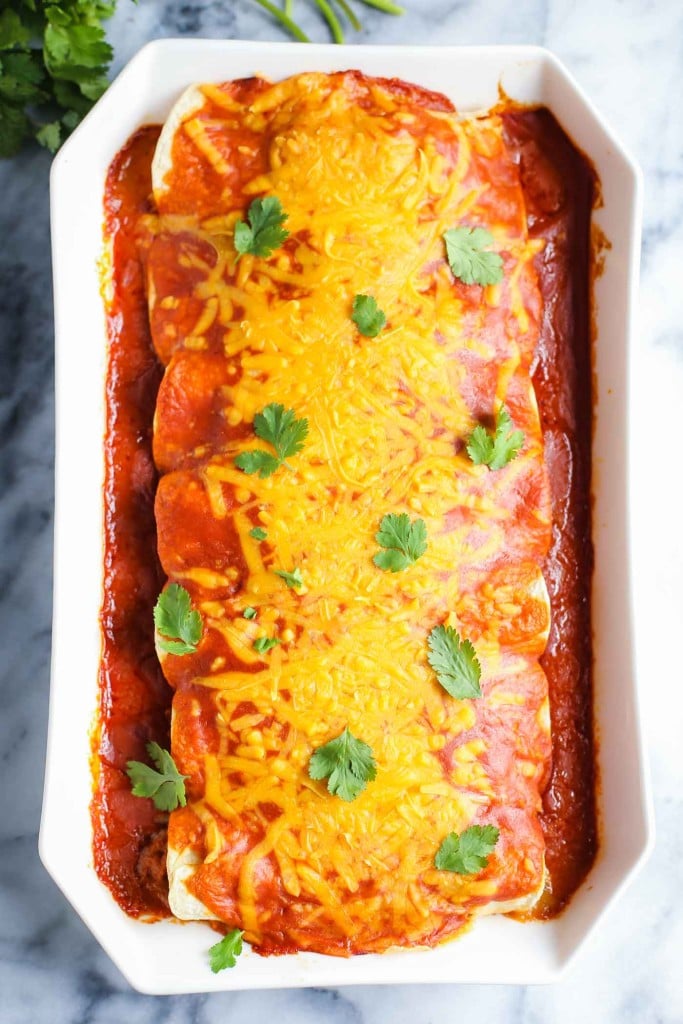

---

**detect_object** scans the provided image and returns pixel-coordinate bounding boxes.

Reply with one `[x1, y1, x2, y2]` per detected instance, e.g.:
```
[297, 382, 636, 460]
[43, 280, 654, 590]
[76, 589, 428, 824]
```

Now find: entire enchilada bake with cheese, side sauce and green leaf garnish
[93, 72, 595, 954]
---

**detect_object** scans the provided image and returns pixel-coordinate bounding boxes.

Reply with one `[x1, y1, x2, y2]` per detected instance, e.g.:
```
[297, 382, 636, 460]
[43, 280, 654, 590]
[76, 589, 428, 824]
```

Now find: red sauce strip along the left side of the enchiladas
[91, 127, 171, 916]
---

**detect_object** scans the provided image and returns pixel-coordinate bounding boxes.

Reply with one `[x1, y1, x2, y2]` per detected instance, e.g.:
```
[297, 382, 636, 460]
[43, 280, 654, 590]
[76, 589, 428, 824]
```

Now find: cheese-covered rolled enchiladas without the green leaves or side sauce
[146, 73, 551, 954]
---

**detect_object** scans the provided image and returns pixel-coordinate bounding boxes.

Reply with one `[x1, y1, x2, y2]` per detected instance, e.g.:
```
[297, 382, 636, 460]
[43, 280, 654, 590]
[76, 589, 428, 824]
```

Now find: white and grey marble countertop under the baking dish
[0, 0, 683, 1024]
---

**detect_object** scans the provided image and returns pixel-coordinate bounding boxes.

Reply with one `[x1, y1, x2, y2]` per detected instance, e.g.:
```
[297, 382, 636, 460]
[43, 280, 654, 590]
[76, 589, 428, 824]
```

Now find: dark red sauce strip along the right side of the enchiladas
[504, 110, 597, 918]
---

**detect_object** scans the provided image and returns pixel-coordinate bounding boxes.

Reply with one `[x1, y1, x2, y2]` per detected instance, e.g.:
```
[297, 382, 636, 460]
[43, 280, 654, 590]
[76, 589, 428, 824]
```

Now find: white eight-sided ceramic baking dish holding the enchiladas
[40, 40, 652, 993]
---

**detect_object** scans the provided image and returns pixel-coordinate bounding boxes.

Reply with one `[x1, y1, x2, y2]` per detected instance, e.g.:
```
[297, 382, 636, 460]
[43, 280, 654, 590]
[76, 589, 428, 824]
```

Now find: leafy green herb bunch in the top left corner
[0, 0, 132, 157]
